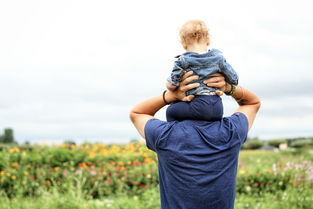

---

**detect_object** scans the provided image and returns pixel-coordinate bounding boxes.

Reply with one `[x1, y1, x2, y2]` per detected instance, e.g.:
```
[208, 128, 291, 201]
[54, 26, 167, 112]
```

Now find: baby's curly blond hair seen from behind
[179, 20, 210, 45]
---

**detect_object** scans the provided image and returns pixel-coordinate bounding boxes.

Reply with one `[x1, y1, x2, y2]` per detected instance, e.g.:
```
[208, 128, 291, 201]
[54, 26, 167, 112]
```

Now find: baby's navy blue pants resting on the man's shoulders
[166, 95, 223, 121]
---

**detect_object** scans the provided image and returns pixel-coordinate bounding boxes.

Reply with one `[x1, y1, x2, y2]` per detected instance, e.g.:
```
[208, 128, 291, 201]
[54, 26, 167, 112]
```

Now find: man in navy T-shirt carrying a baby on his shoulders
[130, 72, 261, 209]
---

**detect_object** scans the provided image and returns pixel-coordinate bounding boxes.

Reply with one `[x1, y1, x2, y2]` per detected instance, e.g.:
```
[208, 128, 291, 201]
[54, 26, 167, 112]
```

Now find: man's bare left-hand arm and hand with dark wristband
[130, 71, 200, 138]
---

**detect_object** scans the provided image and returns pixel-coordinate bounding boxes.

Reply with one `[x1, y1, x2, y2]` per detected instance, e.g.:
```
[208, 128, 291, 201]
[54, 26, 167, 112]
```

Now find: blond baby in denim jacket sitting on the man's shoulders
[166, 20, 238, 121]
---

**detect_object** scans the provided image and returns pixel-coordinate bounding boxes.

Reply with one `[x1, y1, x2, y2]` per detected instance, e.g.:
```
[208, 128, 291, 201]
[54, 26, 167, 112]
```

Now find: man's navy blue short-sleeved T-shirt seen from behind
[145, 113, 248, 209]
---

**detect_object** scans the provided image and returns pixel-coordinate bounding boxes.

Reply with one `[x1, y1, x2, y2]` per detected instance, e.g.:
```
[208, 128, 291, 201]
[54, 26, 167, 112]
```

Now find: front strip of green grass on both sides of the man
[0, 185, 313, 209]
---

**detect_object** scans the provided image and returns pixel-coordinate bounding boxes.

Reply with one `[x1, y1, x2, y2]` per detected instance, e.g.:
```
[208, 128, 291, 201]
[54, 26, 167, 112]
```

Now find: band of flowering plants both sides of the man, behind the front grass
[0, 143, 313, 198]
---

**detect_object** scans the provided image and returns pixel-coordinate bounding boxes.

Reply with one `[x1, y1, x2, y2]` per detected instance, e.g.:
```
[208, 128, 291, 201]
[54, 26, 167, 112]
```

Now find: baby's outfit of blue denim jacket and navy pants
[166, 49, 238, 121]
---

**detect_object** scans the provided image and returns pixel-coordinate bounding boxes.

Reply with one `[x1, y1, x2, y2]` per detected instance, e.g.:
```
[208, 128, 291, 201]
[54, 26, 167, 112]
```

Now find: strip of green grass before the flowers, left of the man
[0, 189, 160, 209]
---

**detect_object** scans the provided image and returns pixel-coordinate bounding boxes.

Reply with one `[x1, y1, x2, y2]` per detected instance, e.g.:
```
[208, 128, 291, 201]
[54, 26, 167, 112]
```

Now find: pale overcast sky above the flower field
[0, 0, 313, 144]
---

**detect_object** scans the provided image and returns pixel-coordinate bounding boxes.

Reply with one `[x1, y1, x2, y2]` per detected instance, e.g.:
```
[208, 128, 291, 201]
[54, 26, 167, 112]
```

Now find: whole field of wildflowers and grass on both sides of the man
[0, 143, 313, 209]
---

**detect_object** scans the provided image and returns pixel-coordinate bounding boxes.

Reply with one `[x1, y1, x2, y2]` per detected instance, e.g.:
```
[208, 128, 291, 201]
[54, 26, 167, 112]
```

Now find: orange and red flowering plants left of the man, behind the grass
[0, 144, 158, 198]
